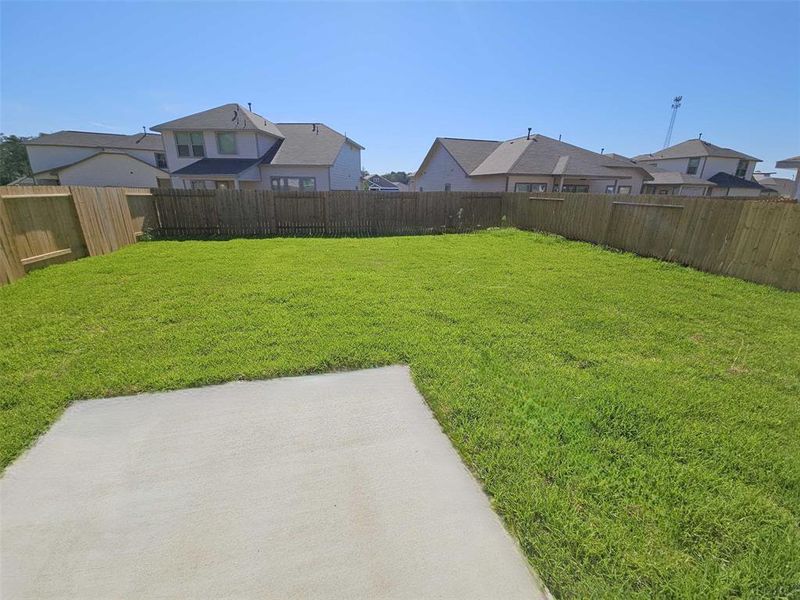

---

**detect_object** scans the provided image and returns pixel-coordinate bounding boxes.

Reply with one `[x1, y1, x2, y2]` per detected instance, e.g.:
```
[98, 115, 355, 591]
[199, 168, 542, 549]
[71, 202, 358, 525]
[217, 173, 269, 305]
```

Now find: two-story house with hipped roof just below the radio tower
[632, 138, 768, 196]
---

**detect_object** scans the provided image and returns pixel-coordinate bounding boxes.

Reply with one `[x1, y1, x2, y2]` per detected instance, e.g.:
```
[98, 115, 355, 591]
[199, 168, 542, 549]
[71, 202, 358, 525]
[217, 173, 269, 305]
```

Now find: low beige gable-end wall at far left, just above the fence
[59, 154, 169, 187]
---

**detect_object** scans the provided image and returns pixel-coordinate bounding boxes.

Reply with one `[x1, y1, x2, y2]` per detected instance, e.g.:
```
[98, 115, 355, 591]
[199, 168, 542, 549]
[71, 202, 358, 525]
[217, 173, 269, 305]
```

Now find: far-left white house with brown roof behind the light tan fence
[21, 131, 169, 187]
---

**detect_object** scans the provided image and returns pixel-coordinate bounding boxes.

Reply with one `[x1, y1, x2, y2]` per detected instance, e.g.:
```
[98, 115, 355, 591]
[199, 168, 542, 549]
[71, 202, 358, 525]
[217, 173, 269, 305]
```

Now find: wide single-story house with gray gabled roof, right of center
[413, 133, 652, 194]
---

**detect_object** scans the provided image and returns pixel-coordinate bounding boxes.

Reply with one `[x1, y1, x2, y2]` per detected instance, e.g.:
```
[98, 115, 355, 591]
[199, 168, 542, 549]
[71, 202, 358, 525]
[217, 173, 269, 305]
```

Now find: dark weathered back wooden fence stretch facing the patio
[153, 189, 503, 238]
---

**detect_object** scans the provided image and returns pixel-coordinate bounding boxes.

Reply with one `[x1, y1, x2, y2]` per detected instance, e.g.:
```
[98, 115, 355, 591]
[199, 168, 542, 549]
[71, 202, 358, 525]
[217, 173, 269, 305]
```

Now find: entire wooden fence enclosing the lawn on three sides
[0, 186, 800, 290]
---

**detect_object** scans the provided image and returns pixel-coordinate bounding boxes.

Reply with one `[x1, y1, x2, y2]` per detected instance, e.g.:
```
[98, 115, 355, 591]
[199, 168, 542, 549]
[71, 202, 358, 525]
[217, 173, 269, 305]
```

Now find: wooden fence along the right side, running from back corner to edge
[509, 194, 800, 290]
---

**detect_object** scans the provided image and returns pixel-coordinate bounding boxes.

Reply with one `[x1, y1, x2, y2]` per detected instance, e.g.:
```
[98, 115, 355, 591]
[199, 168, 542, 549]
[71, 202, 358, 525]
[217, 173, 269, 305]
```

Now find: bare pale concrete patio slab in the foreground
[0, 367, 545, 600]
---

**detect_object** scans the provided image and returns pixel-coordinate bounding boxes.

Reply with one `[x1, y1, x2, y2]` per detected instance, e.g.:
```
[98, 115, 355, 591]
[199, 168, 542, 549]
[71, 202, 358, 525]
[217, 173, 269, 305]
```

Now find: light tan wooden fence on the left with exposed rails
[0, 186, 155, 285]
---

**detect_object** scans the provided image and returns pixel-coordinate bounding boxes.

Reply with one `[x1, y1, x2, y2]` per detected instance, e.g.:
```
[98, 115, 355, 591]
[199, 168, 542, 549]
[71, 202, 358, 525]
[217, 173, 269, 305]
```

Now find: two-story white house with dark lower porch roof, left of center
[151, 104, 364, 191]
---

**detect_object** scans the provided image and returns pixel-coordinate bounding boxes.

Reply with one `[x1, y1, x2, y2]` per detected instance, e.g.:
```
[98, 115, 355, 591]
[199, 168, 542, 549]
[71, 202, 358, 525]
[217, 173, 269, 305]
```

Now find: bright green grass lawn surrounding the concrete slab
[0, 230, 800, 598]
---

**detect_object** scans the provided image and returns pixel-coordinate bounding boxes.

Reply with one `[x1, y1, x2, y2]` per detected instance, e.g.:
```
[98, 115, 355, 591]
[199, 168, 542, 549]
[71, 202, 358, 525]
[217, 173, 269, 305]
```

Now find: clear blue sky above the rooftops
[0, 1, 800, 174]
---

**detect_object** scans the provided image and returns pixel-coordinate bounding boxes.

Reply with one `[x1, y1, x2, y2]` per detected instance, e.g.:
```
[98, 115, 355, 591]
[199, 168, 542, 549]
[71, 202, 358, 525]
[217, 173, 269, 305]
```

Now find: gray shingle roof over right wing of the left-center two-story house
[263, 123, 363, 166]
